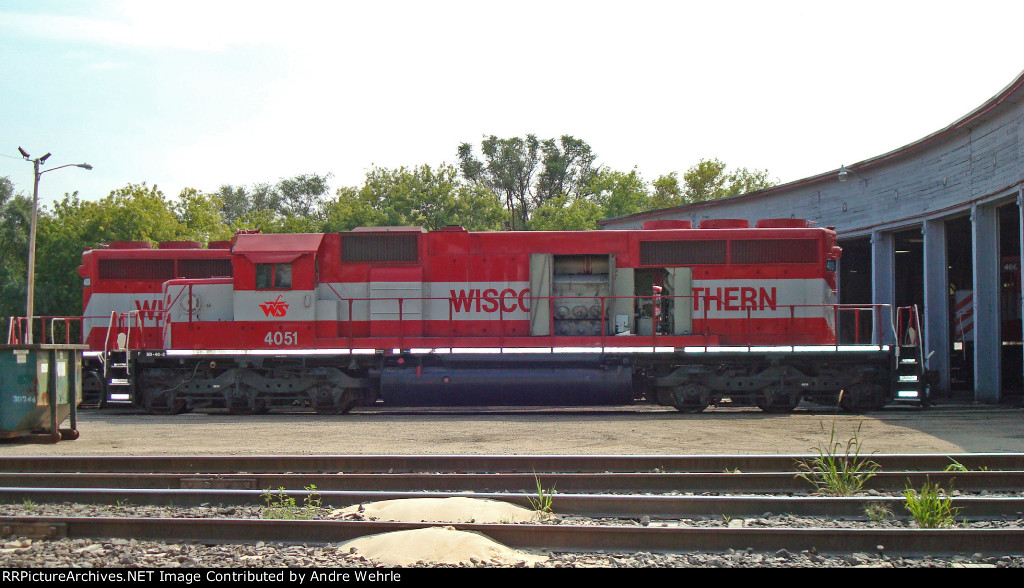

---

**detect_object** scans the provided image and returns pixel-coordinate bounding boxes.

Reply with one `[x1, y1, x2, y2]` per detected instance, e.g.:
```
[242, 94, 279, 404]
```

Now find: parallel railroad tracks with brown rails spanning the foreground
[0, 454, 1024, 555]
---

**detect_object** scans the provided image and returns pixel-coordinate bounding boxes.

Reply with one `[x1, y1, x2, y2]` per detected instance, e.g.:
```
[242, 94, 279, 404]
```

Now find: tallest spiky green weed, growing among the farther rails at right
[797, 420, 882, 496]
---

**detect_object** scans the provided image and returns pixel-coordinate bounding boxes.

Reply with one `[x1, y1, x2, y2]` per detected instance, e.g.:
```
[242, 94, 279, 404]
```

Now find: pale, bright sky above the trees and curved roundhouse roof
[0, 0, 1024, 212]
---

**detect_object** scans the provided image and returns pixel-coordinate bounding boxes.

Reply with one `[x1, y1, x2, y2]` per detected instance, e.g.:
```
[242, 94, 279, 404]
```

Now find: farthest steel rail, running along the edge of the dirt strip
[0, 453, 1024, 473]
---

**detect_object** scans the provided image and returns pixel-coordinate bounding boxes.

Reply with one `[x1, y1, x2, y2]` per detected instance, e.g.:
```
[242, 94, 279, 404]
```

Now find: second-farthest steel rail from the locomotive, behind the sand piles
[0, 471, 1024, 494]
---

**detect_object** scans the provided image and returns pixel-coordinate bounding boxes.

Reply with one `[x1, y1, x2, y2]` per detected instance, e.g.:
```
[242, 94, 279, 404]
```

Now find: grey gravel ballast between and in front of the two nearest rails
[0, 504, 1024, 569]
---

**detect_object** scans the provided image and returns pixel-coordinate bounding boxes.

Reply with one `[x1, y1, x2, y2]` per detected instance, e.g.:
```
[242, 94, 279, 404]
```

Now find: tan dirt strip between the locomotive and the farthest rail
[0, 404, 1024, 458]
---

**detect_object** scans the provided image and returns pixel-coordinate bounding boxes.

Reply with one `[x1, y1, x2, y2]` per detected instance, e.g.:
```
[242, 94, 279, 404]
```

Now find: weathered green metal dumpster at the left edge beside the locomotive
[0, 344, 87, 443]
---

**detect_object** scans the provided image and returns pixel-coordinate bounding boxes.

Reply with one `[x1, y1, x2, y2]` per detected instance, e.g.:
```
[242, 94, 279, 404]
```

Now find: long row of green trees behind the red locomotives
[0, 146, 771, 323]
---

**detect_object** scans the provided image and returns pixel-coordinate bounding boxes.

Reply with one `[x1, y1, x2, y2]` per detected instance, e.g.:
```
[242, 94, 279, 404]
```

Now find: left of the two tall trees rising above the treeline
[458, 134, 541, 230]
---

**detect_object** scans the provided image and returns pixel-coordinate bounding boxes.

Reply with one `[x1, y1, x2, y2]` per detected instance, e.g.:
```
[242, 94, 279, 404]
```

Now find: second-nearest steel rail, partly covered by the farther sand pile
[0, 488, 1024, 519]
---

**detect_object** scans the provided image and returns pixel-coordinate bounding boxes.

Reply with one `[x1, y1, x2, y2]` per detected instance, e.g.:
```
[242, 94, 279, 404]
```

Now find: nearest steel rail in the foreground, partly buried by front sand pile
[0, 516, 1024, 555]
